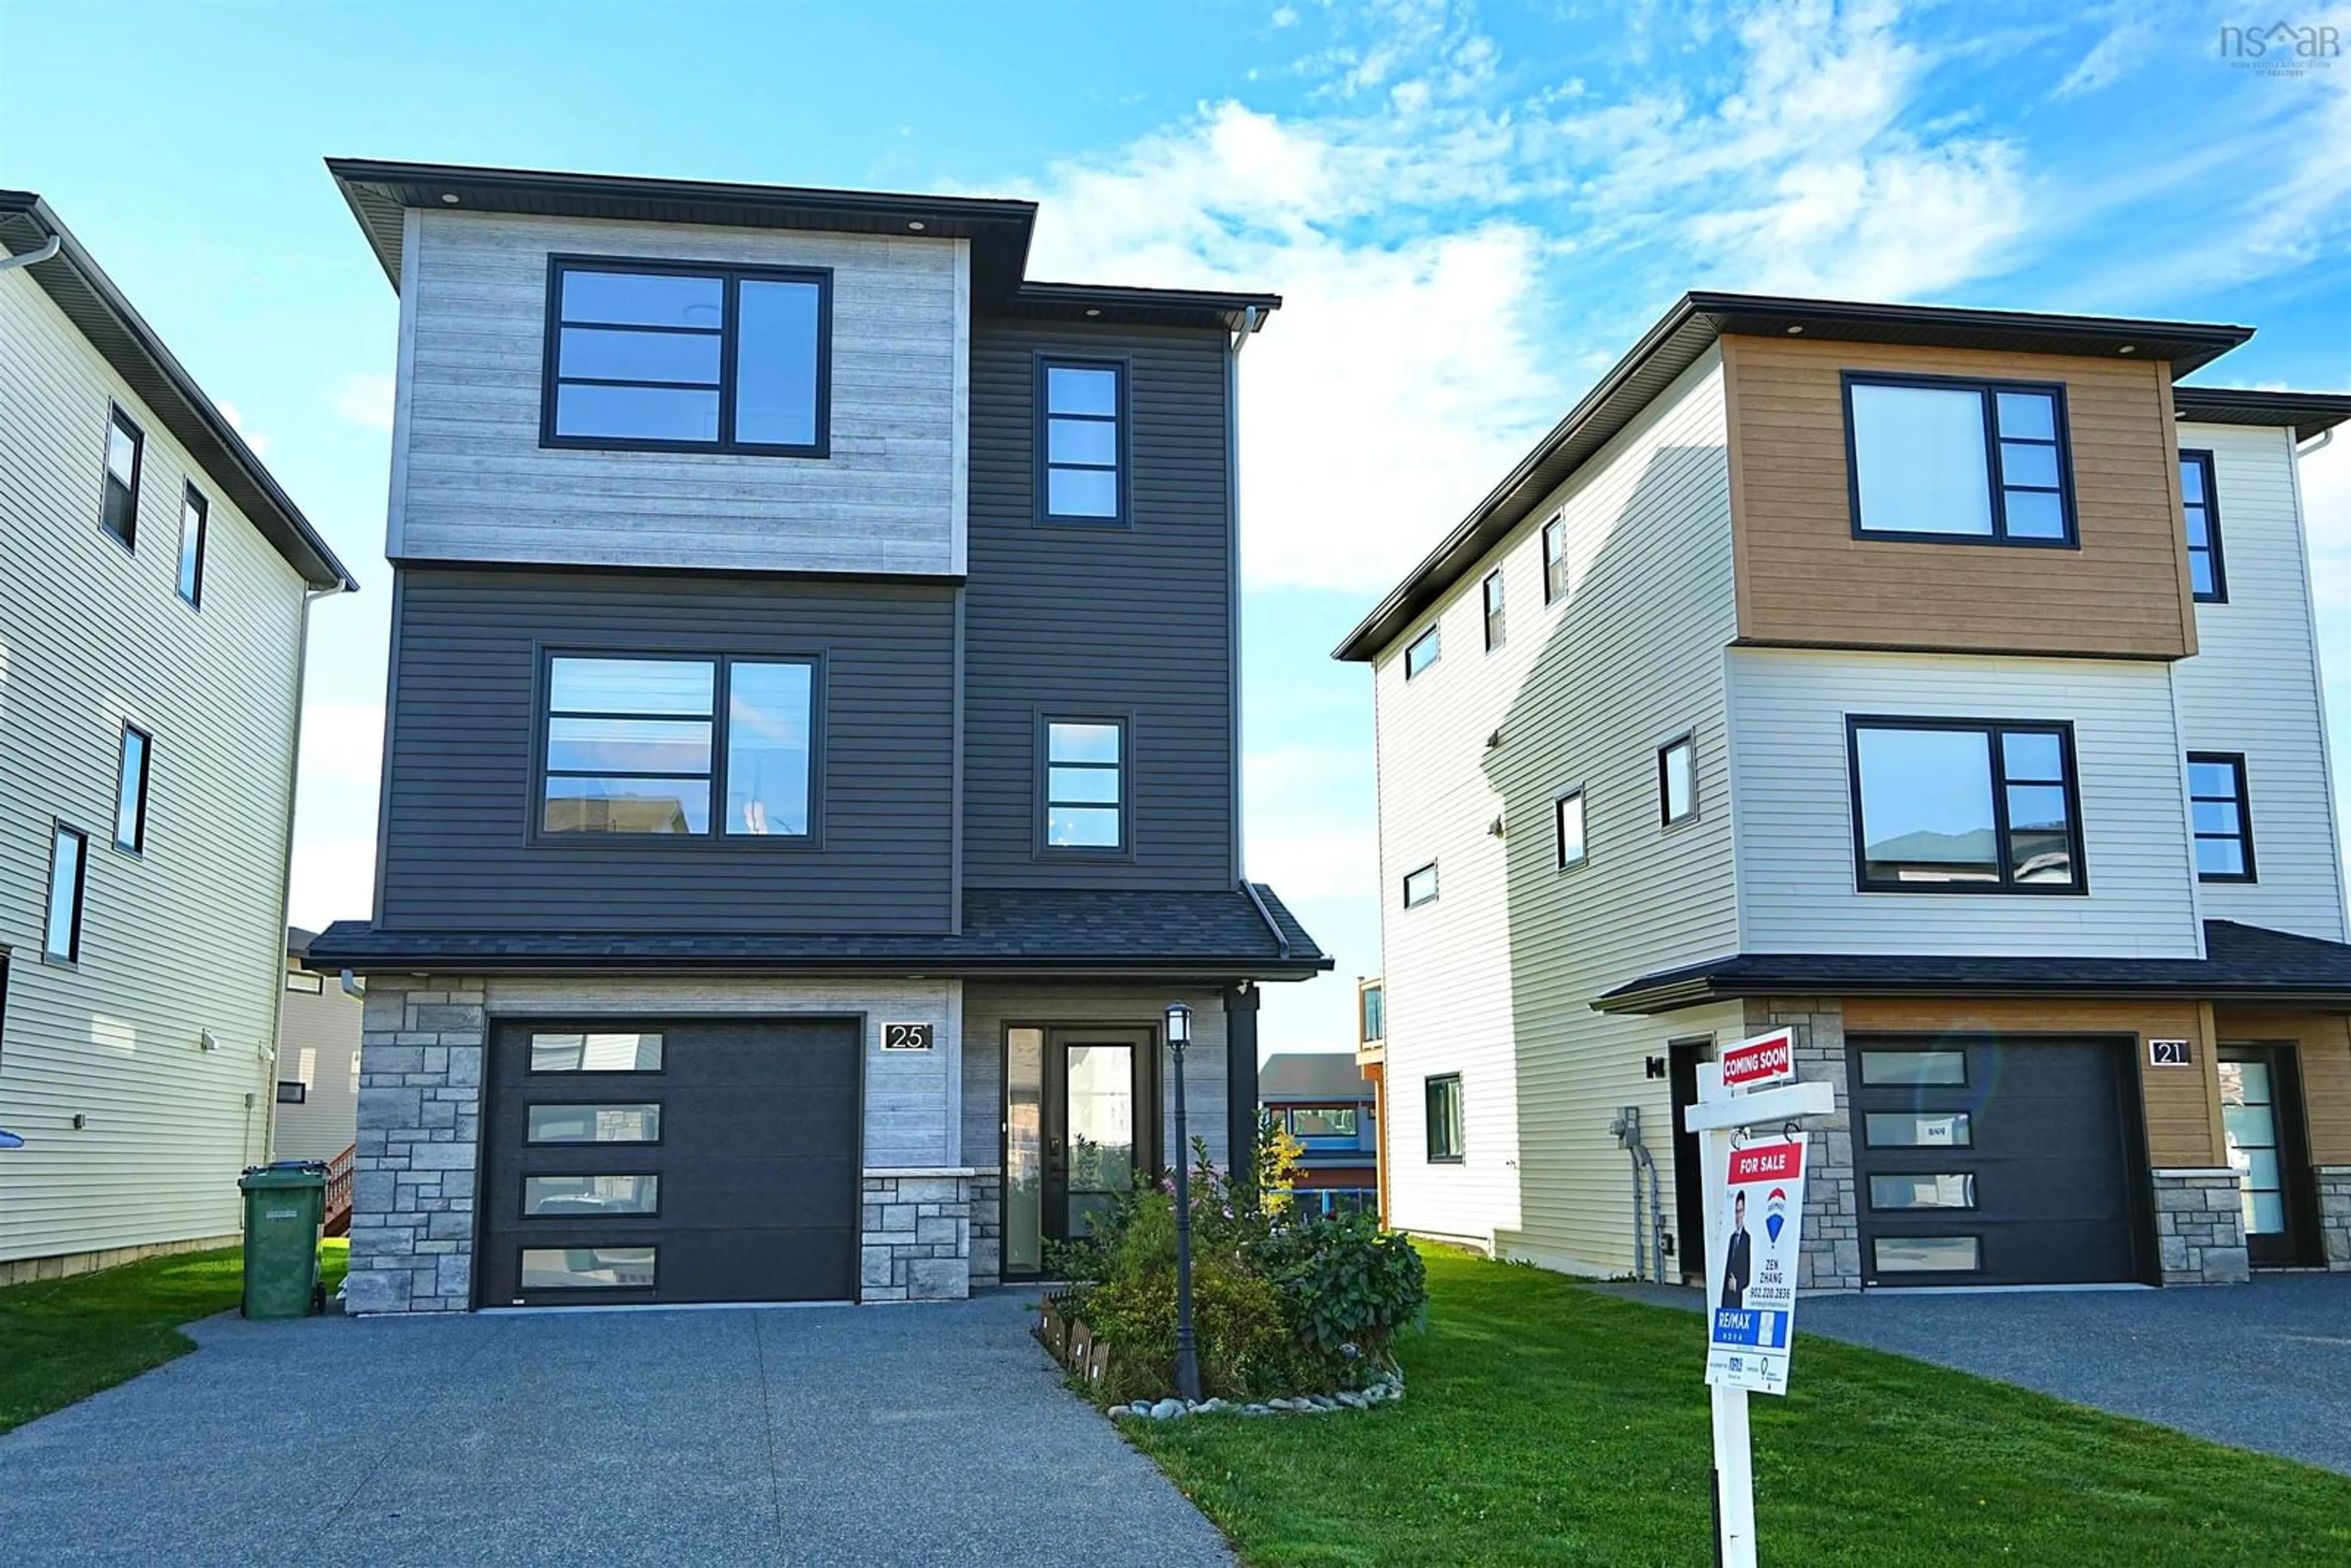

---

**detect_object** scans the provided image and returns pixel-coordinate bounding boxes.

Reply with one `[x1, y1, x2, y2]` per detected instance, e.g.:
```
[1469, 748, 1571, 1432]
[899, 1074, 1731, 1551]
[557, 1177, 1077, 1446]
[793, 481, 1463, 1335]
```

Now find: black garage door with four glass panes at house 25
[475, 1018, 863, 1307]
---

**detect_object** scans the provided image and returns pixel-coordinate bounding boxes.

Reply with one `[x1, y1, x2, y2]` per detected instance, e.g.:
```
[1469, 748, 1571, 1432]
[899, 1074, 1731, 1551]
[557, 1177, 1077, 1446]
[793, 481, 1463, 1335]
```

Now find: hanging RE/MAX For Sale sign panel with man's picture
[1707, 1133, 1803, 1394]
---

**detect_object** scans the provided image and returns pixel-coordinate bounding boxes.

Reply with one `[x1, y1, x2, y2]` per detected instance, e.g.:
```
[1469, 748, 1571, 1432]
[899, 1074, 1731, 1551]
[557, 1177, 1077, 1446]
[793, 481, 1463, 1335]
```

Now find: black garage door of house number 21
[1850, 1034, 2153, 1286]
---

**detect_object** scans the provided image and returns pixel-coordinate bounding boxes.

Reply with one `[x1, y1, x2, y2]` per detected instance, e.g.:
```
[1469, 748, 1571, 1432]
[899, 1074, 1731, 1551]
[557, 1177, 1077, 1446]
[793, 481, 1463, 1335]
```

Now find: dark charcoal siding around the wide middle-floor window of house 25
[378, 569, 954, 931]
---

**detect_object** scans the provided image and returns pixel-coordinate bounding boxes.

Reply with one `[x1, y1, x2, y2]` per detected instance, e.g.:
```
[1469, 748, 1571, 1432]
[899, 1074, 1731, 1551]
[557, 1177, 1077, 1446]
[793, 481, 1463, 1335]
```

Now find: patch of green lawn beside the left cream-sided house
[0, 1237, 350, 1431]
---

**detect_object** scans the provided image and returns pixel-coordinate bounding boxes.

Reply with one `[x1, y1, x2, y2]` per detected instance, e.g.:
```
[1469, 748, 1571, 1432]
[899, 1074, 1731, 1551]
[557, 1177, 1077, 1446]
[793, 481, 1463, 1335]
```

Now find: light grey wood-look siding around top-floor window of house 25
[390, 212, 966, 571]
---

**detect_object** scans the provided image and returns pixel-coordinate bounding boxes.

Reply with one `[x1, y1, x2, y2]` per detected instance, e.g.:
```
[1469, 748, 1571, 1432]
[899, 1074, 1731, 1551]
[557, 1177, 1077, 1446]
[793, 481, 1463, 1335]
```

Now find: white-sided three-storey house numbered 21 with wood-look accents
[1338, 294, 2351, 1291]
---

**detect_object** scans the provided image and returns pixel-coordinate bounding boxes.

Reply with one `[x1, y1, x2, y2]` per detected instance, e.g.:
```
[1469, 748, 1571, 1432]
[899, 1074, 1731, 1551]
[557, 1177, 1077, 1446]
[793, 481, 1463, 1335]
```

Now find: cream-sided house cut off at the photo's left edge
[0, 193, 353, 1283]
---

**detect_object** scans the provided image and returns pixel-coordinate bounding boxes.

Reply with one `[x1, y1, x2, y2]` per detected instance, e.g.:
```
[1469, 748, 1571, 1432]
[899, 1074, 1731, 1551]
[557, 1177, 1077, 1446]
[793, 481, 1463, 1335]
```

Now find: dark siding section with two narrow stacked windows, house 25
[964, 317, 1237, 888]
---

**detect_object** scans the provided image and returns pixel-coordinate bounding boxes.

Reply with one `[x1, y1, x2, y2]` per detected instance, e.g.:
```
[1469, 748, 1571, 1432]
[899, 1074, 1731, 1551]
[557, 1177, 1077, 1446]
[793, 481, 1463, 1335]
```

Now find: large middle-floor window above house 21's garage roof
[1845, 719, 2085, 893]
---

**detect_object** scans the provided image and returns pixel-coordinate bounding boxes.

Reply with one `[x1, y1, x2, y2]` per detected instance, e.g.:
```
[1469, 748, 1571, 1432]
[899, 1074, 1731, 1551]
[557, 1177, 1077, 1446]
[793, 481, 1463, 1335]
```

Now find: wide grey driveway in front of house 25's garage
[0, 1293, 1232, 1568]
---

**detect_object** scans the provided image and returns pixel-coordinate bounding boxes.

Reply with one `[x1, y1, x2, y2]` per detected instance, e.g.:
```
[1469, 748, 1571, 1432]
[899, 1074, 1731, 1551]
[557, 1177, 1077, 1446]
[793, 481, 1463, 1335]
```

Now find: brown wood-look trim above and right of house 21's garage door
[1845, 997, 2226, 1171]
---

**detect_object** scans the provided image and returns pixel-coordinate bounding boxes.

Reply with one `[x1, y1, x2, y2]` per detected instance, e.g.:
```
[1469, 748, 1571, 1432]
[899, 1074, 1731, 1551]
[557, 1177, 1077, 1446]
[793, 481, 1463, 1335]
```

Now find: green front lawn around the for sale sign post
[1119, 1248, 2351, 1568]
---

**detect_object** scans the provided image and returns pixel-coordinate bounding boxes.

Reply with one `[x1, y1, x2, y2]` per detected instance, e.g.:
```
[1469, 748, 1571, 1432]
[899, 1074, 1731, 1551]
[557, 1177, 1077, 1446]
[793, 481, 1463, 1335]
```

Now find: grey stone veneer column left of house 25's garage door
[348, 975, 484, 1311]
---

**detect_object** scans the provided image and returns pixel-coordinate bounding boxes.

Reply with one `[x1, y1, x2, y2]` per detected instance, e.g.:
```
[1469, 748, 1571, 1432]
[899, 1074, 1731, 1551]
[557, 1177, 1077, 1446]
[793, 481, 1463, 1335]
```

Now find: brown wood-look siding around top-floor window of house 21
[1723, 336, 2196, 658]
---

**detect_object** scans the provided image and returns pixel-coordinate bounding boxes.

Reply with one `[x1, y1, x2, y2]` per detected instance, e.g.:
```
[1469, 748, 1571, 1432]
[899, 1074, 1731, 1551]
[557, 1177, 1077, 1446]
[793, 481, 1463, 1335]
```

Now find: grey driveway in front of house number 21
[1601, 1274, 2351, 1474]
